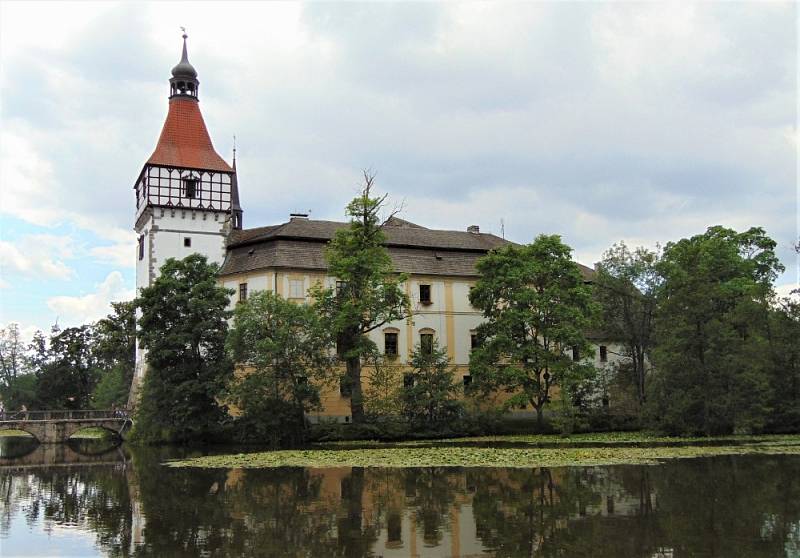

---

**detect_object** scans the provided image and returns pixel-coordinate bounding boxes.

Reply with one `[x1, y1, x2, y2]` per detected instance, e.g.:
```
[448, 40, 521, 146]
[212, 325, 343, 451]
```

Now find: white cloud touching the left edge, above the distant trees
[0, 234, 75, 280]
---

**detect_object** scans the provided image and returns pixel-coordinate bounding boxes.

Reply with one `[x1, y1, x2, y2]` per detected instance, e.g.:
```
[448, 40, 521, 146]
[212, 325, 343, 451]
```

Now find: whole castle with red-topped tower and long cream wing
[134, 35, 619, 422]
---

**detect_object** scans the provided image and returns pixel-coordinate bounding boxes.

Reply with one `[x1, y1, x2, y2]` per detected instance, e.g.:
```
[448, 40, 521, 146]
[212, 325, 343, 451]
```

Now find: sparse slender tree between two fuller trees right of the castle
[594, 242, 661, 406]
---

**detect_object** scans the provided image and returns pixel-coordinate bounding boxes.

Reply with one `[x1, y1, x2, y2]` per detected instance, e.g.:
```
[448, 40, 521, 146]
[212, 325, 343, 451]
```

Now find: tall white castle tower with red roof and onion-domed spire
[132, 34, 242, 398]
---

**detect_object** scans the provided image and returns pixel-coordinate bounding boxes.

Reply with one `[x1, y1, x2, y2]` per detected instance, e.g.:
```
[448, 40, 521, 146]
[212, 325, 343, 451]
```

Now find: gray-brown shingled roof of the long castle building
[220, 218, 592, 278]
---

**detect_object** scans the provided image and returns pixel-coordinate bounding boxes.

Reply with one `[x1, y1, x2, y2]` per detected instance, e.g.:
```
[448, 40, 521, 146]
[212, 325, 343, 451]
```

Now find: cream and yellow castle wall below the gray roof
[220, 269, 622, 421]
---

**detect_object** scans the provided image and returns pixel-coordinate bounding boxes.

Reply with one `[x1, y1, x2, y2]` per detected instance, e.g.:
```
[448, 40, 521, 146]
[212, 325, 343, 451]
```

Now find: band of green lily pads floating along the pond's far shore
[167, 434, 800, 468]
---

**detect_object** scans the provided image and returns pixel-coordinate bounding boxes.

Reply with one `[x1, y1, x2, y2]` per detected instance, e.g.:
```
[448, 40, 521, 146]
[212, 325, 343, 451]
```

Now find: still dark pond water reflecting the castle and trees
[0, 439, 800, 558]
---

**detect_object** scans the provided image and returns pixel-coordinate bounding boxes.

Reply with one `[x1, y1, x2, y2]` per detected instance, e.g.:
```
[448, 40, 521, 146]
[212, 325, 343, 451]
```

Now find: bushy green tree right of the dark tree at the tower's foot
[228, 291, 333, 443]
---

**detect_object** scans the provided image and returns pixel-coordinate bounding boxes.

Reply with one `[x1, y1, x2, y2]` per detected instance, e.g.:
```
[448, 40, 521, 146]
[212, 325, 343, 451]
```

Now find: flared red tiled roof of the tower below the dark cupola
[147, 97, 233, 172]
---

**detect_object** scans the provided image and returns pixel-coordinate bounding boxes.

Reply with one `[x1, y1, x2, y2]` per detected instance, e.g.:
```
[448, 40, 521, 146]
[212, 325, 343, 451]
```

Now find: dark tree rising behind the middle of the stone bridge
[36, 325, 99, 409]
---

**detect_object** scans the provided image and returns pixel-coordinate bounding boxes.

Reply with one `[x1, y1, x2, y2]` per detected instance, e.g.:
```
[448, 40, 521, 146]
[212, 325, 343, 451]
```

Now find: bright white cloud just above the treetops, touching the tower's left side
[47, 271, 135, 325]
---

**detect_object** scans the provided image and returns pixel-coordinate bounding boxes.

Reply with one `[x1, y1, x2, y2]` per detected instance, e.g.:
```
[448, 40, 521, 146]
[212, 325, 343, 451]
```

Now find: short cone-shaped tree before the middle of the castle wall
[401, 342, 463, 428]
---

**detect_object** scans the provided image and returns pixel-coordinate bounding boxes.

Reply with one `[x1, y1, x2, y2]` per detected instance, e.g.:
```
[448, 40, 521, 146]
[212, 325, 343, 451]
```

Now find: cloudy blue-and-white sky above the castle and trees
[0, 1, 800, 334]
